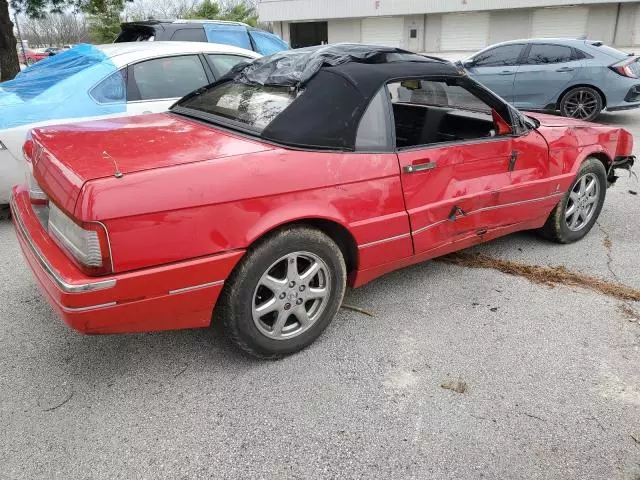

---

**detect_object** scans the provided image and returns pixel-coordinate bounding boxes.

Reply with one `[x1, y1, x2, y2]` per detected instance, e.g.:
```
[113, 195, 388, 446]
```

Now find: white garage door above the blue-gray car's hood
[440, 13, 489, 51]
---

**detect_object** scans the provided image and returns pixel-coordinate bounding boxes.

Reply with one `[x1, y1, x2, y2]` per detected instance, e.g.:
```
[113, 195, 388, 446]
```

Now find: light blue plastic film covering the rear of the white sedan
[0, 44, 126, 129]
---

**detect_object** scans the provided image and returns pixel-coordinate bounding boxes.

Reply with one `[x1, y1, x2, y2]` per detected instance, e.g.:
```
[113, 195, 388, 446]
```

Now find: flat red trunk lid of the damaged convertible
[32, 113, 273, 212]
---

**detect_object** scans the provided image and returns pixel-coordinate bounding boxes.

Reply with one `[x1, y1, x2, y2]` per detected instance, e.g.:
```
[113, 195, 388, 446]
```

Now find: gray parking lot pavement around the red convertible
[0, 113, 640, 480]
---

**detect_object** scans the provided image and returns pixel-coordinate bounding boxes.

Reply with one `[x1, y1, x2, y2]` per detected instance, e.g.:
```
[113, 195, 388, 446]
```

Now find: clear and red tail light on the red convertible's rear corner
[48, 202, 112, 275]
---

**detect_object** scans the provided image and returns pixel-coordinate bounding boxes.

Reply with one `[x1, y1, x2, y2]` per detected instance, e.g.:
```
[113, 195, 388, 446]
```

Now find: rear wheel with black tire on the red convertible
[215, 227, 347, 359]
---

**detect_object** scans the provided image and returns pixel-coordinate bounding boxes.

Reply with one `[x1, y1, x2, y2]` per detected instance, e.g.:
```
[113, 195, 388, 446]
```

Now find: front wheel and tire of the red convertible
[541, 157, 607, 243]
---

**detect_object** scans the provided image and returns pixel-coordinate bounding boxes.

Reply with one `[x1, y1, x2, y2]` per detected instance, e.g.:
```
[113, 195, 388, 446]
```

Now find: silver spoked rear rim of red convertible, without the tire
[252, 251, 331, 340]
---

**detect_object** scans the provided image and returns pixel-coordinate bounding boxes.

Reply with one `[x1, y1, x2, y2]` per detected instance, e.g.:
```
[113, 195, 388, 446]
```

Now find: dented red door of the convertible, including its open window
[388, 79, 513, 254]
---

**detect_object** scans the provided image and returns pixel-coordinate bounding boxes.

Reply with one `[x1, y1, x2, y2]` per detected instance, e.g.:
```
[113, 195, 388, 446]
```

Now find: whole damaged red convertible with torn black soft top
[11, 45, 633, 358]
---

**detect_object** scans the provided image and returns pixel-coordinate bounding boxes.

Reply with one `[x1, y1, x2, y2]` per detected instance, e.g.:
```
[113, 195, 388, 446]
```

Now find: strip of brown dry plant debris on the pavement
[437, 252, 640, 302]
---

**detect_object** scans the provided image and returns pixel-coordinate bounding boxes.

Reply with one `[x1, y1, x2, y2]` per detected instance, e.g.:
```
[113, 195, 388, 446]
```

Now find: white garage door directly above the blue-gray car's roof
[531, 7, 589, 38]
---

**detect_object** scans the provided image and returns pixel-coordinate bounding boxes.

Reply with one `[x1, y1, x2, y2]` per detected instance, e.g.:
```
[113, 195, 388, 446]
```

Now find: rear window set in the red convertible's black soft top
[178, 82, 300, 132]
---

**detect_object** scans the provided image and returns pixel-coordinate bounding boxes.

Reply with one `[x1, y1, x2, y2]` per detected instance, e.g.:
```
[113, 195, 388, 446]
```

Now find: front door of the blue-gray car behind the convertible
[464, 43, 525, 102]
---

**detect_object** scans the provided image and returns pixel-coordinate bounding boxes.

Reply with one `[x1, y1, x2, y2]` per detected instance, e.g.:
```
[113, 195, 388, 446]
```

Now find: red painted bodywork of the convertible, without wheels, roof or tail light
[14, 109, 632, 333]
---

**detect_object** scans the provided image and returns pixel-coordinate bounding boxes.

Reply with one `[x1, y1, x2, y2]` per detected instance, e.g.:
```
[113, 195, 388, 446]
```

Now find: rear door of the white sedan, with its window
[127, 54, 214, 115]
